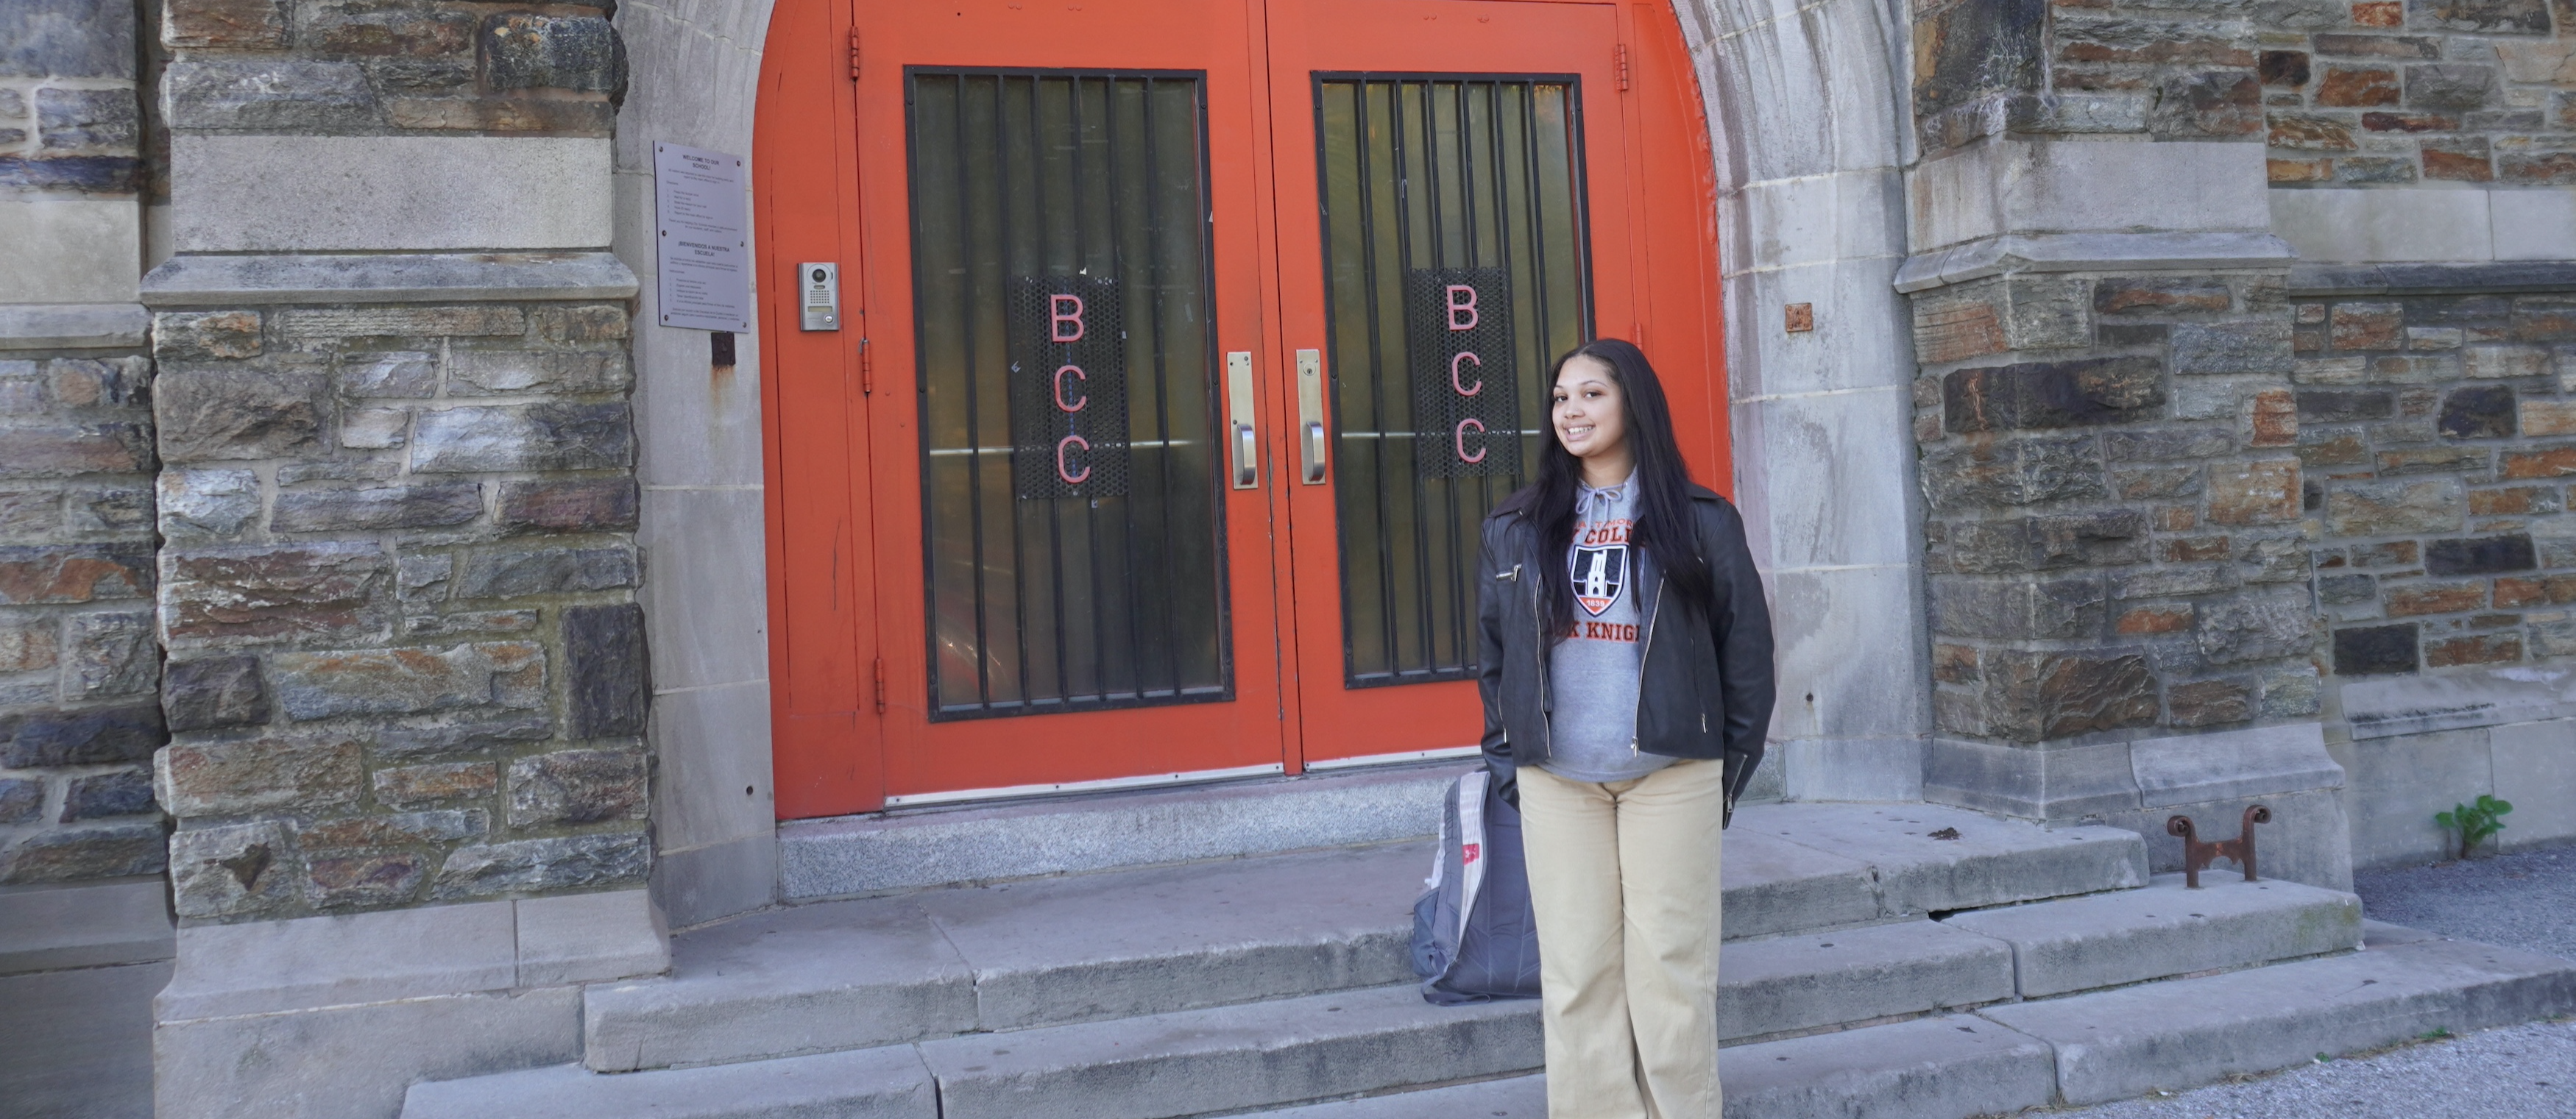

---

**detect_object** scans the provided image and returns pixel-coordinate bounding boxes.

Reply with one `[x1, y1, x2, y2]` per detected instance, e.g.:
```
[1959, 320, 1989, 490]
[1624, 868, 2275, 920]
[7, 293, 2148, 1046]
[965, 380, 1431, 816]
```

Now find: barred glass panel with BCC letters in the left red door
[907, 69, 1231, 720]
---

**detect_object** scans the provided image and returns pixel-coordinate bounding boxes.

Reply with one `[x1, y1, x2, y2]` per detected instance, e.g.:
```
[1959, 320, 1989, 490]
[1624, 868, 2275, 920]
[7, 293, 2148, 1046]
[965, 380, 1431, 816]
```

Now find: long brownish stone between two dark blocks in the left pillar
[268, 641, 546, 720]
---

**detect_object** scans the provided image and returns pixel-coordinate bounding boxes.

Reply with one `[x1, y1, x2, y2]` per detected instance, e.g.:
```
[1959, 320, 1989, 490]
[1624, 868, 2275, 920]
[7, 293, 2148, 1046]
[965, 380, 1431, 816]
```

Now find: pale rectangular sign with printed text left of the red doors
[652, 144, 752, 332]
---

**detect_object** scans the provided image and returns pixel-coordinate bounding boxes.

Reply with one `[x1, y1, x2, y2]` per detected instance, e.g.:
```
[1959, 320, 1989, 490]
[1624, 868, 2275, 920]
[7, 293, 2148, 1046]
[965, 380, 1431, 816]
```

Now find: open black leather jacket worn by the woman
[1476, 486, 1775, 818]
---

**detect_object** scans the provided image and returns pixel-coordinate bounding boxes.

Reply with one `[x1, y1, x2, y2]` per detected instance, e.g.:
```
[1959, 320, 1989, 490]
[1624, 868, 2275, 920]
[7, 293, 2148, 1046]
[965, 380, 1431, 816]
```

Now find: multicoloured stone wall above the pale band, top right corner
[2262, 0, 2576, 188]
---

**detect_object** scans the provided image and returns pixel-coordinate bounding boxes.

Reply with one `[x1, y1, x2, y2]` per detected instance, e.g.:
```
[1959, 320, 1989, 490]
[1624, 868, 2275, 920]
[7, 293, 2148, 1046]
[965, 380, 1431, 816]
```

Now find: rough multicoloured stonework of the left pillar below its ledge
[155, 304, 649, 921]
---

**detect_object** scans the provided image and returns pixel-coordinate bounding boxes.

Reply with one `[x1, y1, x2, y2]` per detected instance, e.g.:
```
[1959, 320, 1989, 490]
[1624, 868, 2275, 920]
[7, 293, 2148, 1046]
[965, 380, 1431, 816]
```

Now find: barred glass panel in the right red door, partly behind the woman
[1317, 74, 1592, 687]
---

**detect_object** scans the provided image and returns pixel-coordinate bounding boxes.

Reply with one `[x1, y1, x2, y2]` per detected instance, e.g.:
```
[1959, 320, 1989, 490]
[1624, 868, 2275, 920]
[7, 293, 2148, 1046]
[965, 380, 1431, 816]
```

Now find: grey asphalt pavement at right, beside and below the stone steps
[2050, 846, 2576, 1119]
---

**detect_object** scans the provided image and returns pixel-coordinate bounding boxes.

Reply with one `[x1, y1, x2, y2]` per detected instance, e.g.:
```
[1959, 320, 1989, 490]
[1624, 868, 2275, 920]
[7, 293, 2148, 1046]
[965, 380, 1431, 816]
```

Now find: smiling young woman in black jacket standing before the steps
[1479, 340, 1772, 1119]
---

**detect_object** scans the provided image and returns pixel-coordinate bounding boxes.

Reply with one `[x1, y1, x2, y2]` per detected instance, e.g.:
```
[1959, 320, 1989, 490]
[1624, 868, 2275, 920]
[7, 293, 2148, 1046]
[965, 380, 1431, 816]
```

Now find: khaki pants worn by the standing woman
[1520, 761, 1726, 1119]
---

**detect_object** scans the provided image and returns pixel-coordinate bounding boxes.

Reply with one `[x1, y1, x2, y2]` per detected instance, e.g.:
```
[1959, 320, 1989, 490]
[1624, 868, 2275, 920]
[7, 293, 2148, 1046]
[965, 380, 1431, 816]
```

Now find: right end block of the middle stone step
[1947, 875, 2363, 998]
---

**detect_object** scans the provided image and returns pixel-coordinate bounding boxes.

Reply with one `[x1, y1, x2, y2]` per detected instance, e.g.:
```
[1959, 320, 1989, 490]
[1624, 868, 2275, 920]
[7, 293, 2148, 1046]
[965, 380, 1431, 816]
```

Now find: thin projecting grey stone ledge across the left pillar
[142, 252, 639, 309]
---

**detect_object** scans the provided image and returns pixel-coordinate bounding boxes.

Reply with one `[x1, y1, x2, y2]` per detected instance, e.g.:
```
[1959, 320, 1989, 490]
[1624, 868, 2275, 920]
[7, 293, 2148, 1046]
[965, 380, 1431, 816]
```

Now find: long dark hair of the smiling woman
[1499, 337, 1716, 643]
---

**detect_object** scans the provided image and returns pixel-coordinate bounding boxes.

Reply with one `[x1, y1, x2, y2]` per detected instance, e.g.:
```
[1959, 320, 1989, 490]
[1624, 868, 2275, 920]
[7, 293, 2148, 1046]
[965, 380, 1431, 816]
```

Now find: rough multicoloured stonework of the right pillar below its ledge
[1914, 270, 2318, 746]
